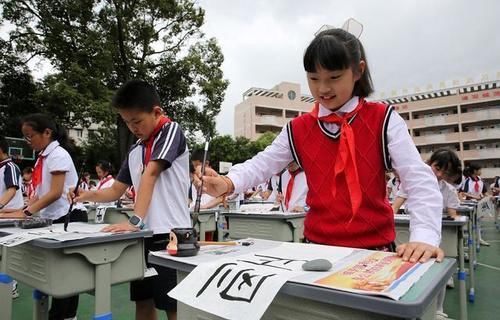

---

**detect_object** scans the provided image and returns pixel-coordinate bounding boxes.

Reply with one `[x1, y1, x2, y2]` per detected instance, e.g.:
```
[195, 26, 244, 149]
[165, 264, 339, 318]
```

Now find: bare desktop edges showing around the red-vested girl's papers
[148, 241, 456, 318]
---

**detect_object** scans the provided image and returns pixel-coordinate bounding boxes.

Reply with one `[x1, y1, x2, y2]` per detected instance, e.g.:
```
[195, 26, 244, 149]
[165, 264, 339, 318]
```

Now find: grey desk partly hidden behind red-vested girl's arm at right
[394, 215, 466, 320]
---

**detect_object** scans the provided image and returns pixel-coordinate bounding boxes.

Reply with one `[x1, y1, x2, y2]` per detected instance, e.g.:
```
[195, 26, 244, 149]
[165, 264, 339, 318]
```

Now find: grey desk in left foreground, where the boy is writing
[0, 224, 153, 320]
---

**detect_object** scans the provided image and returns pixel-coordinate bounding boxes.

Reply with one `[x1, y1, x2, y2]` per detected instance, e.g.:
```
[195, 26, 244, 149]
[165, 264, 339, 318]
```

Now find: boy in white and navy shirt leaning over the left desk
[71, 80, 191, 320]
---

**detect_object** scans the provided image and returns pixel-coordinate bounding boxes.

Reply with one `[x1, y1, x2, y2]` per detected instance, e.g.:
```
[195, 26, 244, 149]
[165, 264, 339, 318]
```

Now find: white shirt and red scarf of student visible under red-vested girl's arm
[281, 168, 308, 211]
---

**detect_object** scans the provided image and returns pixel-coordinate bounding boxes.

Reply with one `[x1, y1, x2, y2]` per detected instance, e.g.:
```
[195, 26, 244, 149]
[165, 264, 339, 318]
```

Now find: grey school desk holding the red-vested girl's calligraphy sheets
[148, 239, 456, 320]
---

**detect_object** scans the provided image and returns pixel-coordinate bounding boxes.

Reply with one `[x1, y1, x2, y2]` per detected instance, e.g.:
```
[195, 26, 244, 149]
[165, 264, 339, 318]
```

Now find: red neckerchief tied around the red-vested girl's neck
[311, 99, 365, 223]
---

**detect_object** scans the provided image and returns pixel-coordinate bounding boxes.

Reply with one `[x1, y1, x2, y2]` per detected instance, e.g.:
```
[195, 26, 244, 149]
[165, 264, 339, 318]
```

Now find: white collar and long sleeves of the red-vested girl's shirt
[228, 97, 443, 246]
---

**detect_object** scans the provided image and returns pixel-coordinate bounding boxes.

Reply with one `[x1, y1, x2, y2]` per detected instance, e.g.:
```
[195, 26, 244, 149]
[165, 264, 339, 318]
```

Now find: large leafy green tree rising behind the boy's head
[0, 0, 228, 158]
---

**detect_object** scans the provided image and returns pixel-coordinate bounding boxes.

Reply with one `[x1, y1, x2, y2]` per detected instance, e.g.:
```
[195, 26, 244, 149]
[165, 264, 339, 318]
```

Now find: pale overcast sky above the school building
[197, 0, 500, 135]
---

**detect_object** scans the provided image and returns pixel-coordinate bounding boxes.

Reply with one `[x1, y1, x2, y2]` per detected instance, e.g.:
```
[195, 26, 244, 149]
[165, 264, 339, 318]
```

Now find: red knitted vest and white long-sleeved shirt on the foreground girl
[228, 97, 442, 248]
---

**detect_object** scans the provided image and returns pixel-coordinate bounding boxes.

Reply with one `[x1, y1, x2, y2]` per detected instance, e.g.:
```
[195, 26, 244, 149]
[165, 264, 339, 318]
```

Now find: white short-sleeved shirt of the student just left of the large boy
[35, 141, 78, 220]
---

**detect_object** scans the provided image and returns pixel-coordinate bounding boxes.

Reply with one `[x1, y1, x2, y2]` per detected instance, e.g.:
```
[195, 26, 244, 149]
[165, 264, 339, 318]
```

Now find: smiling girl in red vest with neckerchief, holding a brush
[204, 29, 443, 262]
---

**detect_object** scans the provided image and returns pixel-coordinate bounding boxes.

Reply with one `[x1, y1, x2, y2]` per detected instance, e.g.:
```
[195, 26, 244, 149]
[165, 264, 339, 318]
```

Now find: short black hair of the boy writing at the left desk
[111, 80, 161, 112]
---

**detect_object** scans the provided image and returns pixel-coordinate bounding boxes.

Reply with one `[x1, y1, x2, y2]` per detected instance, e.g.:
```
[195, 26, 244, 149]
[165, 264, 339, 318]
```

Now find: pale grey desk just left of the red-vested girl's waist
[224, 211, 306, 242]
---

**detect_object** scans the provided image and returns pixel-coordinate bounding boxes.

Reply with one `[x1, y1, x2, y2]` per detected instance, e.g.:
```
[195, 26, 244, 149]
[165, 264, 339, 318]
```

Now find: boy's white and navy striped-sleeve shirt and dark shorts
[116, 122, 191, 311]
